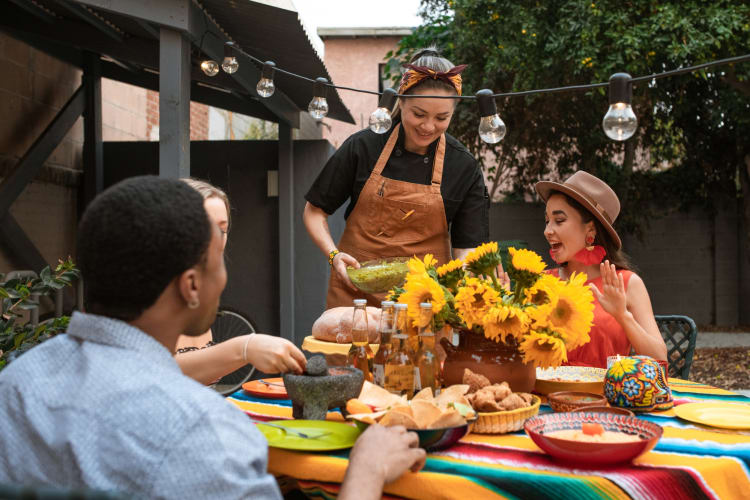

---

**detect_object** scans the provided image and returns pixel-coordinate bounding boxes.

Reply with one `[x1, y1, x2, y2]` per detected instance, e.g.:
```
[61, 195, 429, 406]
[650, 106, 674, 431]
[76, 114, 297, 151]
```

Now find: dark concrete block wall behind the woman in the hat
[490, 203, 750, 325]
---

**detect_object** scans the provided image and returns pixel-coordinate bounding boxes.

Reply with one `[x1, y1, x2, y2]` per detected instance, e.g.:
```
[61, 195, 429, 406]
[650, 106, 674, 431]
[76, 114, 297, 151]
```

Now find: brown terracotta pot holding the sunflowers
[440, 330, 536, 392]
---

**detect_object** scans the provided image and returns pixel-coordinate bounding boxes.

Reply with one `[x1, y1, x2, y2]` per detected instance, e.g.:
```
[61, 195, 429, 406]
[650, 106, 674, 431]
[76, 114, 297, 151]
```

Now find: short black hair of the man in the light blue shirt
[78, 176, 211, 321]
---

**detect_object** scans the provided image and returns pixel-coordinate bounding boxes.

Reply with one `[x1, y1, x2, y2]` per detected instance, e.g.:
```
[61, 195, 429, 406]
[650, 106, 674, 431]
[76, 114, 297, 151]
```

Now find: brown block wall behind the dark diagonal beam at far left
[0, 33, 83, 272]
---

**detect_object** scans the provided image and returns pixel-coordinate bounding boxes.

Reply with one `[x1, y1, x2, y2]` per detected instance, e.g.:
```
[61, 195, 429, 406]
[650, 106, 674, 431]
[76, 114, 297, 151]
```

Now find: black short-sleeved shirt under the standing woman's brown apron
[305, 123, 489, 248]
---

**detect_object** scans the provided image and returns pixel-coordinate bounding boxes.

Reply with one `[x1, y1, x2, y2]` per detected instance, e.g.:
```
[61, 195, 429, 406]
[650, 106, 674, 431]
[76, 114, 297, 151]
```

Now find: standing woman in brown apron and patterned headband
[304, 49, 489, 309]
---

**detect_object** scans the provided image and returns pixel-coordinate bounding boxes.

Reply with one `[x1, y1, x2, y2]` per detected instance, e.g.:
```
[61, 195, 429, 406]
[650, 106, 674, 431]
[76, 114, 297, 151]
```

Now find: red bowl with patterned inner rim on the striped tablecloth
[524, 410, 663, 465]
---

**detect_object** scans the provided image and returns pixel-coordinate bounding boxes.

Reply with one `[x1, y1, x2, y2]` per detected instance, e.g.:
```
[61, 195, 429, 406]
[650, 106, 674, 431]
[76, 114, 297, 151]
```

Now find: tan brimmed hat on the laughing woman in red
[534, 171, 622, 250]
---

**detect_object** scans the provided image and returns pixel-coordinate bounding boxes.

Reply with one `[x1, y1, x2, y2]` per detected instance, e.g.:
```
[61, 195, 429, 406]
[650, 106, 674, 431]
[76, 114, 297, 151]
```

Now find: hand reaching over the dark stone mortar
[245, 333, 307, 374]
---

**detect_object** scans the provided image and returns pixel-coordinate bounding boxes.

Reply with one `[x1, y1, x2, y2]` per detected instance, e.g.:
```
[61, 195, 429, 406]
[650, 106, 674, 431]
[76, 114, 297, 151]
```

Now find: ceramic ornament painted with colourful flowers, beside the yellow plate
[604, 356, 674, 412]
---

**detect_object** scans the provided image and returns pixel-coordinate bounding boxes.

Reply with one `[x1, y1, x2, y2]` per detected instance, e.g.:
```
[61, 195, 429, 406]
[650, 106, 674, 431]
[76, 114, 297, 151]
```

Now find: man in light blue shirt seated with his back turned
[0, 177, 424, 498]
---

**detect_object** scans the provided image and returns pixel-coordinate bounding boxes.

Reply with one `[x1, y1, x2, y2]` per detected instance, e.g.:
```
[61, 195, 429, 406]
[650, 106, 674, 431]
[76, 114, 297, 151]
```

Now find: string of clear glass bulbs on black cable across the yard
[222, 42, 750, 144]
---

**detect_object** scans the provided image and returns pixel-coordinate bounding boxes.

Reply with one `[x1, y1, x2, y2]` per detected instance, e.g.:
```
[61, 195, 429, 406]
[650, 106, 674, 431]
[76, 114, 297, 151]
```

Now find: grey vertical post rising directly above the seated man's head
[159, 28, 190, 179]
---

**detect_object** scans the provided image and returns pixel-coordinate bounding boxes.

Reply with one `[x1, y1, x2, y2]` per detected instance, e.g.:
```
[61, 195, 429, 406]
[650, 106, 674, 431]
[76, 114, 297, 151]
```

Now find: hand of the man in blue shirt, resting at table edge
[339, 424, 426, 500]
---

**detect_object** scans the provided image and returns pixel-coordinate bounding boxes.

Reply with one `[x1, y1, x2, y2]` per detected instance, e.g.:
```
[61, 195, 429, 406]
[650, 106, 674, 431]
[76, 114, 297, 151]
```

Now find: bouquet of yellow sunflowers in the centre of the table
[389, 242, 594, 368]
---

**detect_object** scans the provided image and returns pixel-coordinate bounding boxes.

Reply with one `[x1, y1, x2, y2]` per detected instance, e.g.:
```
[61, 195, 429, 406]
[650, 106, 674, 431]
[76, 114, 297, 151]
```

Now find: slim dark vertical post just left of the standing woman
[279, 122, 296, 342]
